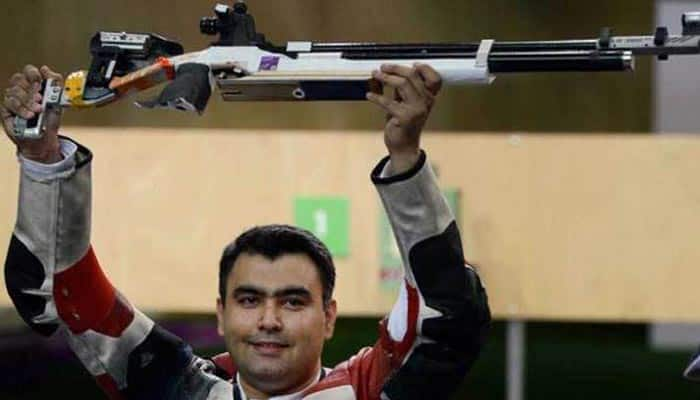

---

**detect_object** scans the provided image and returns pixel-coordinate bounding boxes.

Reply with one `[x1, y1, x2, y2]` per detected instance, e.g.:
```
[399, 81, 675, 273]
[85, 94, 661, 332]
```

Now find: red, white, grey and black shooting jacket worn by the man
[5, 138, 490, 400]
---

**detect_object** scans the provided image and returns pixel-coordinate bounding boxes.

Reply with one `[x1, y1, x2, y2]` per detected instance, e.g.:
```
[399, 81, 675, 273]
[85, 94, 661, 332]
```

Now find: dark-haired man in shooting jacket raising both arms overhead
[1, 65, 490, 400]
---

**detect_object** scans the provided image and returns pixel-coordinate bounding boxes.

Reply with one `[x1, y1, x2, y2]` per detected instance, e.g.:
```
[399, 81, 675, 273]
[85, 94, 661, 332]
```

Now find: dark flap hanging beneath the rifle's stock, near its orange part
[136, 63, 211, 114]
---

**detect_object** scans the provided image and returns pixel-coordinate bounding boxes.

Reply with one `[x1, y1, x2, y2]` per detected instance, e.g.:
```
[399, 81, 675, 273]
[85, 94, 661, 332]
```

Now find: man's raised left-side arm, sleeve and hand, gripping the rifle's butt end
[0, 66, 224, 399]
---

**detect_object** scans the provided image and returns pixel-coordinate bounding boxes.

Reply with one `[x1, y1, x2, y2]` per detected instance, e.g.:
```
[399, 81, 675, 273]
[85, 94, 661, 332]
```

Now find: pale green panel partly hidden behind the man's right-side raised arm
[379, 189, 460, 291]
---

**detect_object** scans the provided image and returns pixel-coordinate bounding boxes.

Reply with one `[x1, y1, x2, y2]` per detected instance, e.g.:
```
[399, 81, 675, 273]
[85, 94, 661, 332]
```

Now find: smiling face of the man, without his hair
[217, 253, 336, 394]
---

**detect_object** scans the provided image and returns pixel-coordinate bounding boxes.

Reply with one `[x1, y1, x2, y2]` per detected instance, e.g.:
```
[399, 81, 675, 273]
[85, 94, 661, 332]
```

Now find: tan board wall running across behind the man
[0, 127, 700, 322]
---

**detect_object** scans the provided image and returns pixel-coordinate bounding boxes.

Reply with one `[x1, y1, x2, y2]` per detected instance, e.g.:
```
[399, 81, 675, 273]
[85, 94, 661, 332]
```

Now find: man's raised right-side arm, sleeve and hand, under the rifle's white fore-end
[342, 65, 491, 400]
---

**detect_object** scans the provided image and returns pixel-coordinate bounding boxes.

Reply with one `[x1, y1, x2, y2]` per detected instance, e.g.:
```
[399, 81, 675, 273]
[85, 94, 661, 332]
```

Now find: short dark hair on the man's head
[219, 225, 335, 306]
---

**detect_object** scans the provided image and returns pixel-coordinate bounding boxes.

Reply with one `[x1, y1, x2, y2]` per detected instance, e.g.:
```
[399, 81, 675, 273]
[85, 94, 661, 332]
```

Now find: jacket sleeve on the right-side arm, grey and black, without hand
[372, 152, 491, 399]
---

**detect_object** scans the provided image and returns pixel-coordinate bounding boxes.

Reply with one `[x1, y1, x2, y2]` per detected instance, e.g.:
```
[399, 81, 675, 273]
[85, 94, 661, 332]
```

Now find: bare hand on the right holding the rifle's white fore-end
[367, 64, 442, 174]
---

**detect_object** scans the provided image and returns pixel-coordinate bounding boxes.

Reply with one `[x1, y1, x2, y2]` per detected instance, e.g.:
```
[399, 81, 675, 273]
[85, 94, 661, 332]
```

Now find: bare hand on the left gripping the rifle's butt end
[0, 65, 63, 164]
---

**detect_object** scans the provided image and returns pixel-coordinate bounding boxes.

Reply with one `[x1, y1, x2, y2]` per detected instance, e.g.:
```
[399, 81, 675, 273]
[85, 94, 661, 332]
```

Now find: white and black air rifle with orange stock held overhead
[15, 0, 700, 138]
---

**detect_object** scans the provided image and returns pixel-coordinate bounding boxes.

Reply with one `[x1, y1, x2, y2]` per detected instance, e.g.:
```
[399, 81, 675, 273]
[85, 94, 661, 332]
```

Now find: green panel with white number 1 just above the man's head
[294, 197, 350, 257]
